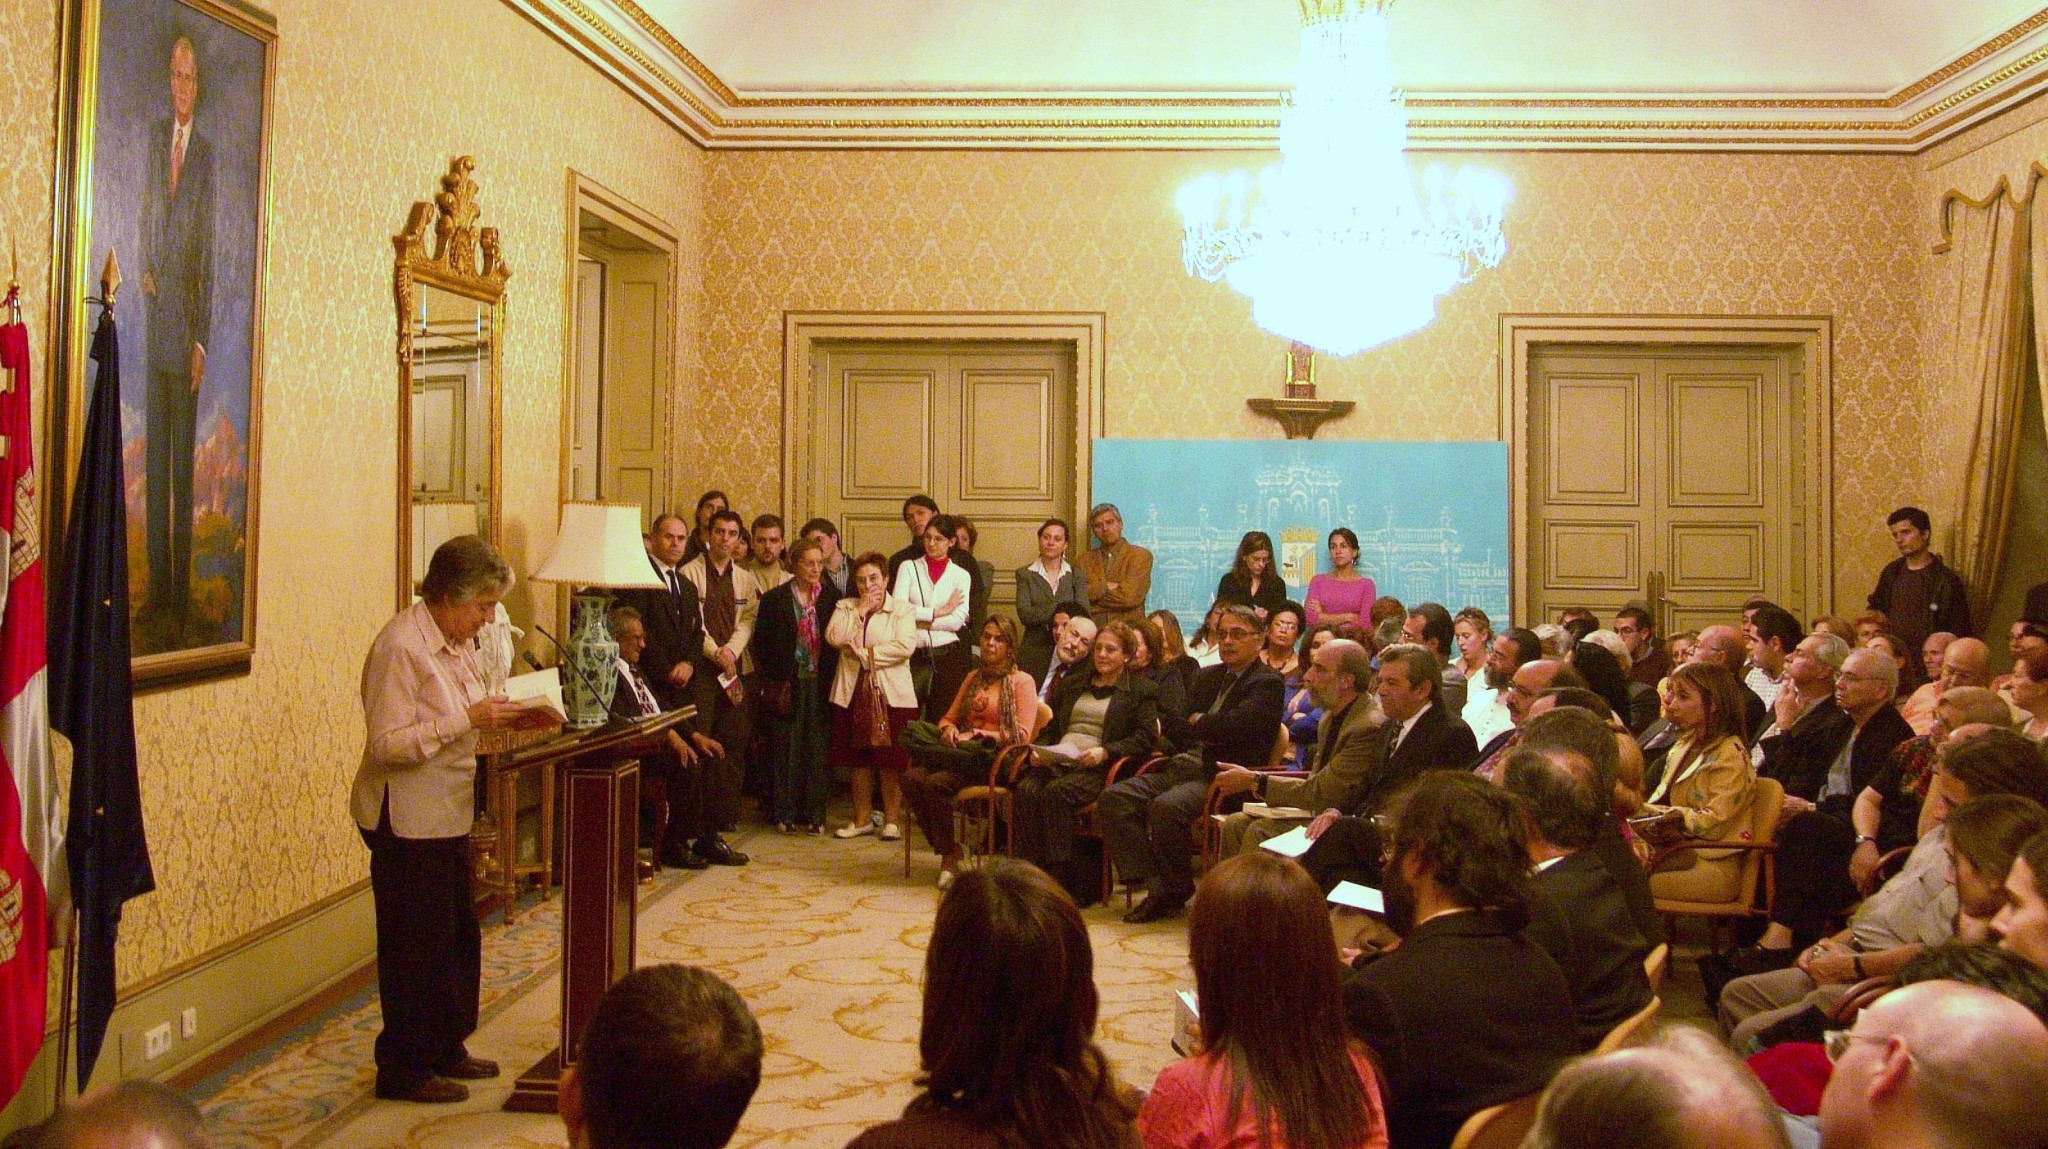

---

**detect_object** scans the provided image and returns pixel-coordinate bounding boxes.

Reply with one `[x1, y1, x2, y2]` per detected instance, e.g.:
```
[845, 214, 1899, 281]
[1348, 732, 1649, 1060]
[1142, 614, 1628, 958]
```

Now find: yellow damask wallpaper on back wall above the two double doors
[700, 152, 1925, 602]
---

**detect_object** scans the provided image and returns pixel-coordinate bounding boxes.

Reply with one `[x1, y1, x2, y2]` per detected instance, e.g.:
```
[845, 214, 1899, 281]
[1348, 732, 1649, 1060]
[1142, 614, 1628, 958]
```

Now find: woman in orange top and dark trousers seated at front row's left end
[901, 614, 1038, 889]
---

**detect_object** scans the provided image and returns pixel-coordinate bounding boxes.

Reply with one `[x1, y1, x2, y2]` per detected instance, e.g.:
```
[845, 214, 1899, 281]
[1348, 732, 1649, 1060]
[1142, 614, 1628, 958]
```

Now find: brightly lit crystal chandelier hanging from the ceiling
[1178, 0, 1507, 354]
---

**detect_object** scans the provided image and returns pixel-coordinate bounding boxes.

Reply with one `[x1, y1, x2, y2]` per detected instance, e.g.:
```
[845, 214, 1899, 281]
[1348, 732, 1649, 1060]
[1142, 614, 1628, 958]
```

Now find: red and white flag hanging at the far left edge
[0, 291, 66, 1104]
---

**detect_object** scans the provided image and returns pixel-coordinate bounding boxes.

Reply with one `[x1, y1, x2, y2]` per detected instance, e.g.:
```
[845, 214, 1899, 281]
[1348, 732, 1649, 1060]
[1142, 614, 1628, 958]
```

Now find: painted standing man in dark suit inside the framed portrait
[141, 37, 213, 616]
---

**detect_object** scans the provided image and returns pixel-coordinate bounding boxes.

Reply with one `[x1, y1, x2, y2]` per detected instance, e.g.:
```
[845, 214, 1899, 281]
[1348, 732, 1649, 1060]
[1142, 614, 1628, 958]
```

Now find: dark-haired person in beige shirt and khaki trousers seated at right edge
[1718, 731, 2048, 1055]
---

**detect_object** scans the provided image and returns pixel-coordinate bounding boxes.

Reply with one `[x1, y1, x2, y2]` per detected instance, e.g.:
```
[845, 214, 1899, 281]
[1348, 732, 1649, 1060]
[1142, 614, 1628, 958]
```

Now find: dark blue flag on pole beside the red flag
[49, 307, 156, 1092]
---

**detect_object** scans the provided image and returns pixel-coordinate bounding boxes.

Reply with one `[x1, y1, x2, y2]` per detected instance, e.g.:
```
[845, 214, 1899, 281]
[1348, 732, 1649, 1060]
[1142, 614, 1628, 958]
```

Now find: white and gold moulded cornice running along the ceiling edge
[508, 0, 2048, 152]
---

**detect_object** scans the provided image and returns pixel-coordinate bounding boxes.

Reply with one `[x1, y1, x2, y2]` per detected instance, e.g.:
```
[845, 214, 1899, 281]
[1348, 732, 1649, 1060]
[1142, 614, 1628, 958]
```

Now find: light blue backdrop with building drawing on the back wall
[1092, 438, 1509, 635]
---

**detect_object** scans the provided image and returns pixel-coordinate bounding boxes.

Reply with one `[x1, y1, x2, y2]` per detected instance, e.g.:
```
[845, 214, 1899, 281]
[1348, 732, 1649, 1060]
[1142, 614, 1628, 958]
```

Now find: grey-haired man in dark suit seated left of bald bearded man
[1096, 606, 1286, 922]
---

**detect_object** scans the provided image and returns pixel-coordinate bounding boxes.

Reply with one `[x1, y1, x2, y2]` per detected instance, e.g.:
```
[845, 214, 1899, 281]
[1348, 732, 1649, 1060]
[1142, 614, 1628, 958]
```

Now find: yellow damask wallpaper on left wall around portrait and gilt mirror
[0, 0, 702, 983]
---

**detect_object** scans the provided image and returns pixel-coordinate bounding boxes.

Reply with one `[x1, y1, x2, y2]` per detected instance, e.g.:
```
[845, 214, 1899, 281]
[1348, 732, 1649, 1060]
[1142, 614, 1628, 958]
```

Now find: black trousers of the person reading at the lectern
[360, 799, 483, 1090]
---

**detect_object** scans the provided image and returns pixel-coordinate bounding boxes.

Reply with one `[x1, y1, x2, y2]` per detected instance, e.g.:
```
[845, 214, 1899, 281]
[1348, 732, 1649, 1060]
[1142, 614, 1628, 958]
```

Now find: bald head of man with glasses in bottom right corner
[1821, 981, 2048, 1149]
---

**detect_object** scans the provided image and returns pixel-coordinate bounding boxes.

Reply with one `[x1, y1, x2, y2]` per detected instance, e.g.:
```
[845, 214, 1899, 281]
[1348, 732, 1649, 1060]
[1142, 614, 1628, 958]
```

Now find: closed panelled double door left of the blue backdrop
[807, 342, 1075, 606]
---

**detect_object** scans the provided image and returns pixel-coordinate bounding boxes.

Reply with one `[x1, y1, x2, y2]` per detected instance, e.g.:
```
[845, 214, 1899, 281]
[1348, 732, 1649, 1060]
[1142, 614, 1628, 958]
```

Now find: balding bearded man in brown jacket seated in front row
[1217, 639, 1384, 856]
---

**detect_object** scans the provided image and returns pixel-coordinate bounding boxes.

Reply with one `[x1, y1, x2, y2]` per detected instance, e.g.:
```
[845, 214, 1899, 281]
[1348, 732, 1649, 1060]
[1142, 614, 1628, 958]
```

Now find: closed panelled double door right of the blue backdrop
[1528, 346, 1804, 633]
